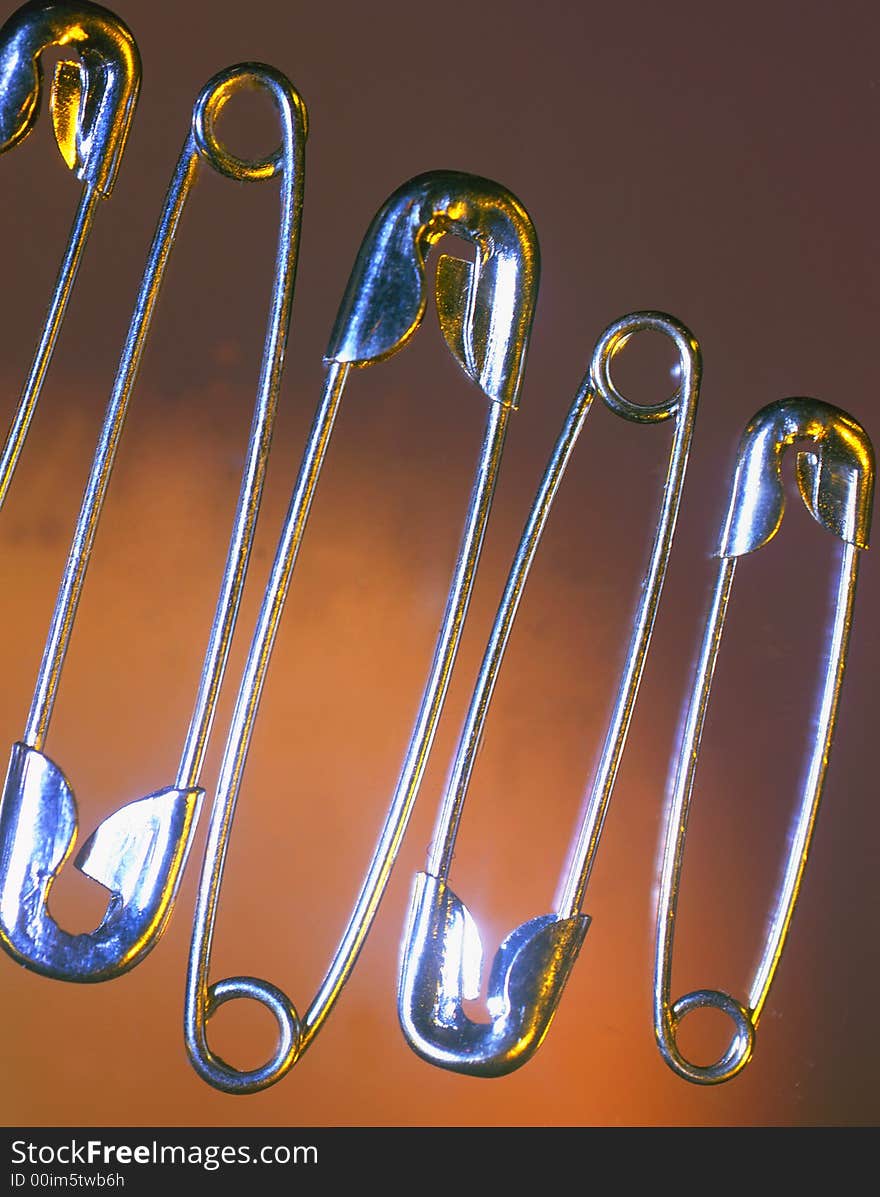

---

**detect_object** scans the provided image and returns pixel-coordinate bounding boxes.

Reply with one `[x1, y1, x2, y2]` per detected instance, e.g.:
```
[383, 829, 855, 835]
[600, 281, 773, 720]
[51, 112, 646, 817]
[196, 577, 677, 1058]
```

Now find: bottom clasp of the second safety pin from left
[0, 743, 204, 982]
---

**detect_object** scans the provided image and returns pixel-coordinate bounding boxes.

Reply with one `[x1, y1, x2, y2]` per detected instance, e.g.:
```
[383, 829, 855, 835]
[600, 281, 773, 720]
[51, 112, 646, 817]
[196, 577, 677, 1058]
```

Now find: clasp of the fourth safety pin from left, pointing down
[399, 873, 590, 1076]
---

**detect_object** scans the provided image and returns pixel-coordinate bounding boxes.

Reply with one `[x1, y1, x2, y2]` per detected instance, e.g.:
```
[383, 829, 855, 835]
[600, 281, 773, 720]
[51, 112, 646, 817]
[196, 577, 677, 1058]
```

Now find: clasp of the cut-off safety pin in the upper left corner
[0, 0, 140, 195]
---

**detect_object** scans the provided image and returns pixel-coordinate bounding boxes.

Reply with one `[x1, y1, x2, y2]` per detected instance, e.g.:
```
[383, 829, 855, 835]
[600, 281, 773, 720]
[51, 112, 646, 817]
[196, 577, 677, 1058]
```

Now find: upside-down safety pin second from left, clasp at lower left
[0, 63, 307, 982]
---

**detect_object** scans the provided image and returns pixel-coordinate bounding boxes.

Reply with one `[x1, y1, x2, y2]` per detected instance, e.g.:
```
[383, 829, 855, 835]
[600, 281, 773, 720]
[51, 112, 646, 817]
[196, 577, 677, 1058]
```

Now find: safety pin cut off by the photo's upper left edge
[0, 0, 140, 506]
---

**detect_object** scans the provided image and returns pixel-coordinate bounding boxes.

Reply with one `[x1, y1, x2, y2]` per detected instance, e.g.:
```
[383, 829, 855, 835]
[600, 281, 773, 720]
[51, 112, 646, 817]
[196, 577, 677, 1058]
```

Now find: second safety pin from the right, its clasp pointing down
[397, 311, 700, 1076]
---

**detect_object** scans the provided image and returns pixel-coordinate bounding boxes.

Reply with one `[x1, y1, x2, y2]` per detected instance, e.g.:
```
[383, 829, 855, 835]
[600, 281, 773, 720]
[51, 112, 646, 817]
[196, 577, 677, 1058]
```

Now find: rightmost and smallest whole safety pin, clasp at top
[654, 399, 874, 1084]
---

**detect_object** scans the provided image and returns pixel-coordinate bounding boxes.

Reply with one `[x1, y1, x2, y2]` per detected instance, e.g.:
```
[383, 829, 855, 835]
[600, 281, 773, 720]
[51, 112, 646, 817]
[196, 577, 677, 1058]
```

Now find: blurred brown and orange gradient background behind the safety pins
[0, 0, 880, 1126]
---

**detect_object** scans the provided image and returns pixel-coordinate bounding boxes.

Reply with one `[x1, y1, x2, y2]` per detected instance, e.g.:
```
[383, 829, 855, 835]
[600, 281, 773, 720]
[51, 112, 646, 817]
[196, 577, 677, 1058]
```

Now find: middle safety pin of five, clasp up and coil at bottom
[184, 171, 539, 1093]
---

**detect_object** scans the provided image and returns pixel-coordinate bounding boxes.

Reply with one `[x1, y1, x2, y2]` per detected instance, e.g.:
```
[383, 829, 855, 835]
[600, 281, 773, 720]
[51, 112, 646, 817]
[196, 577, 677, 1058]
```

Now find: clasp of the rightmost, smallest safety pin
[718, 399, 874, 557]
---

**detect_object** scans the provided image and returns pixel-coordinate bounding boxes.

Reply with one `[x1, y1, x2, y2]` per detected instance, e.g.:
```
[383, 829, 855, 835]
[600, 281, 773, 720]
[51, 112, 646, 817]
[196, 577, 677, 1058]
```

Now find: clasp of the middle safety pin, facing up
[324, 171, 540, 407]
